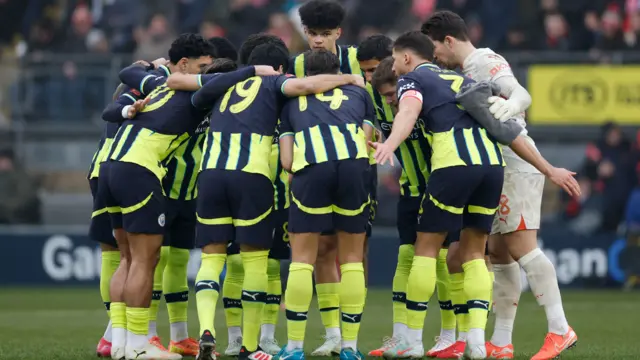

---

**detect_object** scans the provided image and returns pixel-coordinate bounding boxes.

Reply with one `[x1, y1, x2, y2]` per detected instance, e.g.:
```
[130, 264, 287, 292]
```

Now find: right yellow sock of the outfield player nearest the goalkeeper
[462, 259, 491, 330]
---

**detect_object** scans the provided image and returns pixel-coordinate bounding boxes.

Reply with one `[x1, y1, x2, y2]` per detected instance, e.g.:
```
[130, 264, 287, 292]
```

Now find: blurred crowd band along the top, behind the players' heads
[0, 0, 640, 58]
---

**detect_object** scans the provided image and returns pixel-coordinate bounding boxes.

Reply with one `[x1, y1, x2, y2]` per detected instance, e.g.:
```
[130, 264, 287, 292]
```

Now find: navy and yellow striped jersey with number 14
[280, 85, 375, 173]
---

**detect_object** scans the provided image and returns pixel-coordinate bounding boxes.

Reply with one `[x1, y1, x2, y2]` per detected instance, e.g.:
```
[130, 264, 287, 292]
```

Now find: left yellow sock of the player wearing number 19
[196, 253, 227, 336]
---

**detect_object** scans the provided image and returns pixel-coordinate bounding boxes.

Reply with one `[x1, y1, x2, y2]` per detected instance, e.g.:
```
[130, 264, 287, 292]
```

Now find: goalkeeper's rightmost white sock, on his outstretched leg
[518, 249, 569, 335]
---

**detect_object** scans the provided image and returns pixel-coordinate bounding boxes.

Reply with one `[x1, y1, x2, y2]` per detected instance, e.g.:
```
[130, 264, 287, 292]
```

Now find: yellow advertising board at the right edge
[528, 65, 640, 125]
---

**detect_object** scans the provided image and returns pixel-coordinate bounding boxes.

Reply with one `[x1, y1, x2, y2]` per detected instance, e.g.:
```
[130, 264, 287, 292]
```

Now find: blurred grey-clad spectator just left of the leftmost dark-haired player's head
[133, 14, 175, 61]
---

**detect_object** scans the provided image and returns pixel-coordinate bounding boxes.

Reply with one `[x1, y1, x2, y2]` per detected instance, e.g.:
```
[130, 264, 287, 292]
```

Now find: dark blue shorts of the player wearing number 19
[196, 169, 273, 249]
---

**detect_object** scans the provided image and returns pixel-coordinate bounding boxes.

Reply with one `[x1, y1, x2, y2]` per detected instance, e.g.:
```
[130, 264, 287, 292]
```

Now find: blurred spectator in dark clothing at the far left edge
[0, 150, 40, 224]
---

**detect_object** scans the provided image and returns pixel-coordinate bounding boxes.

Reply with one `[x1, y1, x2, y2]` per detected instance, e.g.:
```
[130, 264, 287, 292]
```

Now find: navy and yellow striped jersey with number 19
[201, 75, 289, 180]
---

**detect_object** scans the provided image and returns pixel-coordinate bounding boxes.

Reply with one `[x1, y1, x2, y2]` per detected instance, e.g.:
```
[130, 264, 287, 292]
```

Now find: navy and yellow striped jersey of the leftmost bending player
[108, 66, 211, 180]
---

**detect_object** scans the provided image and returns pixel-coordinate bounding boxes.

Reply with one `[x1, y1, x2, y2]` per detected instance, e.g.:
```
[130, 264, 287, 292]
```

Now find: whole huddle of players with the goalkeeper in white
[89, 0, 579, 360]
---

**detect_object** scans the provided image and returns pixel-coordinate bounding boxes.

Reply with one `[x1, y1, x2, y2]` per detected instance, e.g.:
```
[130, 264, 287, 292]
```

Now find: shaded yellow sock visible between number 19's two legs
[222, 254, 244, 328]
